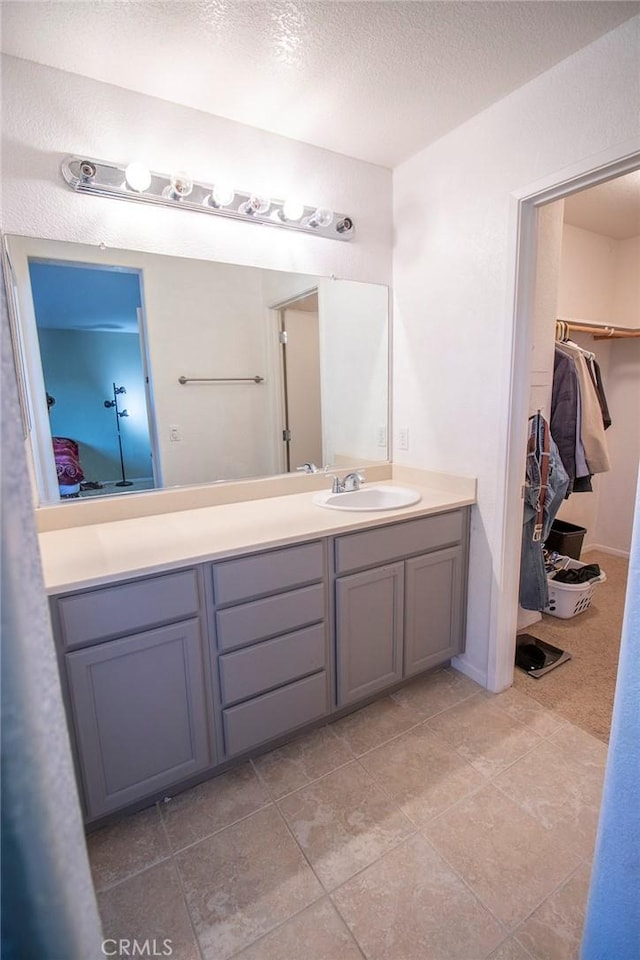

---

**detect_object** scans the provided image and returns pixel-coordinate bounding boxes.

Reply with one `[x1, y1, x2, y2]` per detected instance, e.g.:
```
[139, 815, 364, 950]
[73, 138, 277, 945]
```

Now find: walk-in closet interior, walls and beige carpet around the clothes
[514, 173, 640, 742]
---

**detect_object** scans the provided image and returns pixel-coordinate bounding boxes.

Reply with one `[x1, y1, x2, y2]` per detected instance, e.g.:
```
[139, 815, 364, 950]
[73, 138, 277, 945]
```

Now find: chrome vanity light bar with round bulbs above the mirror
[61, 156, 355, 240]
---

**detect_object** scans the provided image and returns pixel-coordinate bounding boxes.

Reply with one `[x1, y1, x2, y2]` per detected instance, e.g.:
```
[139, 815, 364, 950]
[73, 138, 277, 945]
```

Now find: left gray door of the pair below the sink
[336, 563, 404, 706]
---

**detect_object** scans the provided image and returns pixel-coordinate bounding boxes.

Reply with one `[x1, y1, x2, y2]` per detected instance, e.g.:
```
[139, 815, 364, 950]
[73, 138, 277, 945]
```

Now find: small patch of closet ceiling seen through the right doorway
[564, 171, 640, 240]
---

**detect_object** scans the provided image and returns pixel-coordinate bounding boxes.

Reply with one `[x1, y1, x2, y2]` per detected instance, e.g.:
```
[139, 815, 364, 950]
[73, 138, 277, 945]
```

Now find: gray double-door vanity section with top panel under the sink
[335, 510, 469, 707]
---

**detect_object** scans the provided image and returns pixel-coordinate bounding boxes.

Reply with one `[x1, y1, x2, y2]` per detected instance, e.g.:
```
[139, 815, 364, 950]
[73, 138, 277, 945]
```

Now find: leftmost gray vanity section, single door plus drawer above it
[53, 569, 213, 820]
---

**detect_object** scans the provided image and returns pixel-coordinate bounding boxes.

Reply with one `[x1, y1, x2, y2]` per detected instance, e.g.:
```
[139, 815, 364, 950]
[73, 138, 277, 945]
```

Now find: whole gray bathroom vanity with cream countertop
[41, 472, 474, 823]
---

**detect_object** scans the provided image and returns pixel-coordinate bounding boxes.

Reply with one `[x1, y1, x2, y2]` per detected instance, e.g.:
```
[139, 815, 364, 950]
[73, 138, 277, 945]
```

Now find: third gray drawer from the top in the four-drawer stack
[219, 623, 326, 705]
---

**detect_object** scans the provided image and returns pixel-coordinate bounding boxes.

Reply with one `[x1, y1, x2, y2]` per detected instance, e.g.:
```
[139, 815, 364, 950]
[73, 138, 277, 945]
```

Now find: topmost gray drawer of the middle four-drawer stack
[213, 542, 324, 605]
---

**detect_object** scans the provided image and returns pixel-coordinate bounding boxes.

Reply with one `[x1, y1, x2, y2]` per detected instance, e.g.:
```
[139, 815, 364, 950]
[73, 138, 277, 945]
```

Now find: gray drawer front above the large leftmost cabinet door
[57, 569, 200, 649]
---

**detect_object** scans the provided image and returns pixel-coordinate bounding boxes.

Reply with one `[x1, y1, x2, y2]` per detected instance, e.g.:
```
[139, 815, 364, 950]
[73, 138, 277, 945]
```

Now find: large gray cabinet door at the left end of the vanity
[65, 620, 211, 819]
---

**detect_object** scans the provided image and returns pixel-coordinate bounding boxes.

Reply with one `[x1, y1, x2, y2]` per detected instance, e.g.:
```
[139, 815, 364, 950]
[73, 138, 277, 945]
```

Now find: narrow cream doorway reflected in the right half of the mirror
[278, 290, 323, 473]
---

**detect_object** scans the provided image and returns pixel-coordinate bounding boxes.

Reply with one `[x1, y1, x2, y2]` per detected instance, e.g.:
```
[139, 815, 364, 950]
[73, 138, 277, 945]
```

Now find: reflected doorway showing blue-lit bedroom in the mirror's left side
[29, 258, 157, 499]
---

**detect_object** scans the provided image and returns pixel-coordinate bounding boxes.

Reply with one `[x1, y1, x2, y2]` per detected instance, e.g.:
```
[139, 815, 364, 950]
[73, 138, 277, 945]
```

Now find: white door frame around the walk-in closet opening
[487, 139, 640, 692]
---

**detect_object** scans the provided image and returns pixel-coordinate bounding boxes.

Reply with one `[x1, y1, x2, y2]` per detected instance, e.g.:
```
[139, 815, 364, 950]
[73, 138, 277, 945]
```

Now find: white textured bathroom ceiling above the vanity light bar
[1, 0, 640, 167]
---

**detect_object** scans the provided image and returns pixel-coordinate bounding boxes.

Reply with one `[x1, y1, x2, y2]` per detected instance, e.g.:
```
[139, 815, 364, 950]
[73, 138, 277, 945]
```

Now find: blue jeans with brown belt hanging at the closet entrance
[520, 413, 569, 610]
